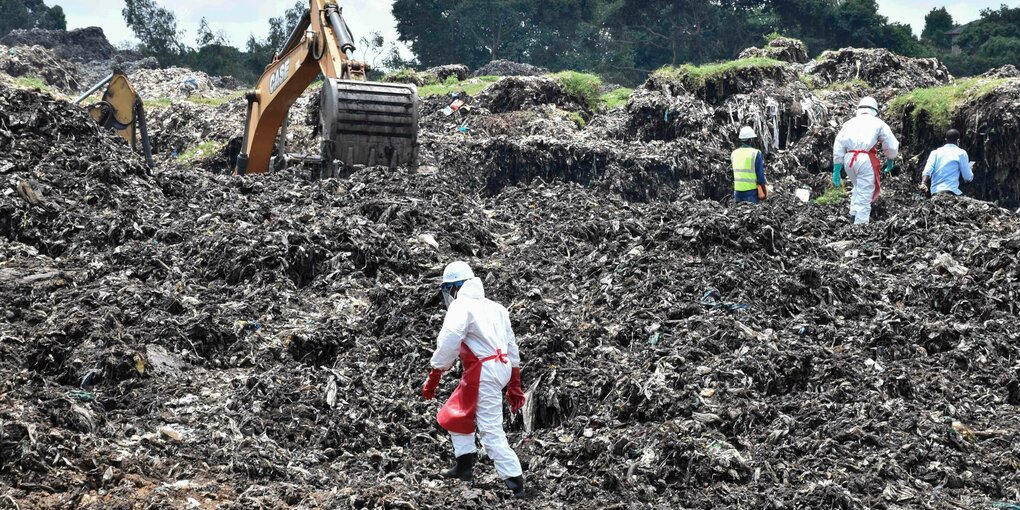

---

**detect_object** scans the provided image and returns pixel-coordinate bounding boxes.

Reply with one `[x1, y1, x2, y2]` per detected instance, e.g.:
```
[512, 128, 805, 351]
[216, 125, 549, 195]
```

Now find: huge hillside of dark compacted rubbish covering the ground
[0, 29, 1020, 510]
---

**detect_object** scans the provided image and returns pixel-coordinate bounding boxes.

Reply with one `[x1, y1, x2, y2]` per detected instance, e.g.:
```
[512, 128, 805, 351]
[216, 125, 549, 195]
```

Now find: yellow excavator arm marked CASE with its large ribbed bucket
[234, 0, 418, 177]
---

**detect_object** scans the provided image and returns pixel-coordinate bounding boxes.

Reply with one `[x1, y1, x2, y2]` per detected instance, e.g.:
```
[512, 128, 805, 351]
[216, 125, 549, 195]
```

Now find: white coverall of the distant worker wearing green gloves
[832, 108, 900, 224]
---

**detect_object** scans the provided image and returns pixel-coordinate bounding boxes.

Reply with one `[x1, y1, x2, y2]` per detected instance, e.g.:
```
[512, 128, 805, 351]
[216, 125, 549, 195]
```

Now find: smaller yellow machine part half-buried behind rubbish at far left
[74, 69, 153, 168]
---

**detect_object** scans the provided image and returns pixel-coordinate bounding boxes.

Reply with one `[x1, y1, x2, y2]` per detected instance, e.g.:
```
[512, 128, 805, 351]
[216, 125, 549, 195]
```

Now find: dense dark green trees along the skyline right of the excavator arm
[393, 0, 1020, 83]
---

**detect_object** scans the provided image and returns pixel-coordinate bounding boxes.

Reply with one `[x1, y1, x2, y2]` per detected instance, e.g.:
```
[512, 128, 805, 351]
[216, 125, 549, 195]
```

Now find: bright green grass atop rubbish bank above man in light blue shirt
[888, 78, 1006, 132]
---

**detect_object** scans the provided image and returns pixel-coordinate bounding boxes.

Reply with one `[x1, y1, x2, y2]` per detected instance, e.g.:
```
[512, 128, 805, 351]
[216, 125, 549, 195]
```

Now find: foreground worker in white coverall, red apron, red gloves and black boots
[421, 261, 524, 498]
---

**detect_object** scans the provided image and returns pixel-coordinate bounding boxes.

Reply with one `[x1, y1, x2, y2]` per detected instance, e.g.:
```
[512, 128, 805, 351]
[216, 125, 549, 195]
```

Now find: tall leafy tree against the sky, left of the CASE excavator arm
[120, 0, 186, 65]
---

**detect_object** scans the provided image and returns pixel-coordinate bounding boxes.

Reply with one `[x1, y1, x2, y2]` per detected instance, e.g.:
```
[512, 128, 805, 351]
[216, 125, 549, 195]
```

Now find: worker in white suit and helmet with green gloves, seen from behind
[832, 97, 900, 224]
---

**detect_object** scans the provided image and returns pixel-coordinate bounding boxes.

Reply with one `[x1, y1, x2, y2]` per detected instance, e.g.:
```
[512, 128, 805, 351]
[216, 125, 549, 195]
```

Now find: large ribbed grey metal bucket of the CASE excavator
[319, 79, 418, 167]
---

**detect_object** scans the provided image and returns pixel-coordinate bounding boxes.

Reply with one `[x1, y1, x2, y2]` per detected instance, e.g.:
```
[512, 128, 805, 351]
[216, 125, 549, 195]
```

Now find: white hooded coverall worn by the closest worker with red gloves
[431, 277, 522, 479]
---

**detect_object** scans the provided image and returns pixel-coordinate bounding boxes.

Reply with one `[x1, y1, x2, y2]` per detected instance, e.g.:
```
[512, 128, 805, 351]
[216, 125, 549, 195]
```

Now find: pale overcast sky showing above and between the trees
[61, 0, 1020, 52]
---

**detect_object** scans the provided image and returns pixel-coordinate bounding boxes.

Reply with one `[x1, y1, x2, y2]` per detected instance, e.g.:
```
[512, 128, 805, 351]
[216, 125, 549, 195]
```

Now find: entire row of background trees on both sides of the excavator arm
[0, 0, 1020, 84]
